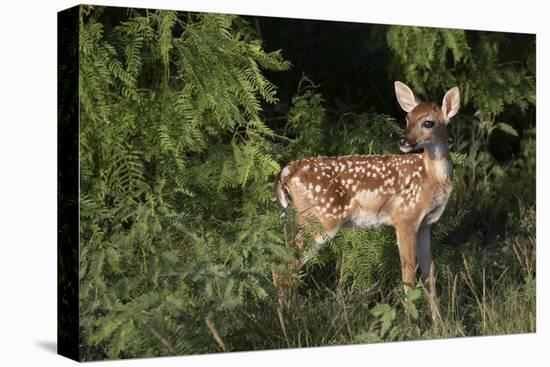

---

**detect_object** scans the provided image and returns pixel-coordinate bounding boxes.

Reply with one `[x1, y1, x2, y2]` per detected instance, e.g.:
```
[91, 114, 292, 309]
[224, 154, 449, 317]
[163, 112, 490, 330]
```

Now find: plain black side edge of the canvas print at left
[54, 6, 80, 359]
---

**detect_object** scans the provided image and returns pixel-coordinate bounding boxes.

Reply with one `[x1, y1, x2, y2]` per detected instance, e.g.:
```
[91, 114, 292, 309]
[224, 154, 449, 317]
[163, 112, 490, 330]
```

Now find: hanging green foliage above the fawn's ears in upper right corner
[387, 26, 535, 114]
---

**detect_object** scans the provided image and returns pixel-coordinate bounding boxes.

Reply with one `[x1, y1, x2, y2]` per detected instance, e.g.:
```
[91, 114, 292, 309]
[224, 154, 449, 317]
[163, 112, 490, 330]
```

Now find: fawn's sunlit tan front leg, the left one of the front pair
[395, 223, 417, 292]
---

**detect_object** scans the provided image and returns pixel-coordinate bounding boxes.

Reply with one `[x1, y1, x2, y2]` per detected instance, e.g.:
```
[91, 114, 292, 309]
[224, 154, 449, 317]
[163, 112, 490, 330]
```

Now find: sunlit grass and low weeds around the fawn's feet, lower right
[232, 209, 536, 350]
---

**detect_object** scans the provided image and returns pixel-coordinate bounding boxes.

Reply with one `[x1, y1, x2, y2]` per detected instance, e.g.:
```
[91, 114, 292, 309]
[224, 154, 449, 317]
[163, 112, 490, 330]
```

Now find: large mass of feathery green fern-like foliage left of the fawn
[80, 7, 296, 359]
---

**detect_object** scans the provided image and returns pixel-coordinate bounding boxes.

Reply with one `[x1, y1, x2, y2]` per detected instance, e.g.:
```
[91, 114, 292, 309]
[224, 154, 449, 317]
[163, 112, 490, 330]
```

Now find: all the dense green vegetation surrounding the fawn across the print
[75, 6, 536, 360]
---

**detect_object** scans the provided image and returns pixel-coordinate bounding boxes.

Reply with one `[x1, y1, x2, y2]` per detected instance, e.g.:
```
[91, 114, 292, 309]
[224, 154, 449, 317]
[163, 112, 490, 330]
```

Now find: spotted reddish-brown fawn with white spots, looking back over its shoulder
[275, 82, 460, 316]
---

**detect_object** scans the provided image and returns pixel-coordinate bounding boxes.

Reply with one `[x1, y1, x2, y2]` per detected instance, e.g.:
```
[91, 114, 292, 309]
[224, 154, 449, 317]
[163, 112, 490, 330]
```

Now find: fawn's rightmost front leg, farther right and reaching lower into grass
[416, 226, 439, 320]
